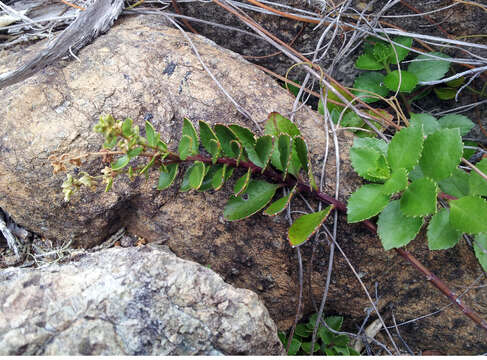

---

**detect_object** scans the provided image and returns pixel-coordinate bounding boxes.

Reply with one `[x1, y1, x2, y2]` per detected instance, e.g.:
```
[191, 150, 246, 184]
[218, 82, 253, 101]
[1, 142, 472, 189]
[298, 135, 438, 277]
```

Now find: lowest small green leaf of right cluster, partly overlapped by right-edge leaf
[426, 209, 462, 250]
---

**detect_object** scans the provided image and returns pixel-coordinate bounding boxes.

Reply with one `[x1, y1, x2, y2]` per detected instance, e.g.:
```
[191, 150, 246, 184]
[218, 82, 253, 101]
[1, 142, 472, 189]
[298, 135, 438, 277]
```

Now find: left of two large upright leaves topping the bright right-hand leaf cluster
[387, 126, 424, 172]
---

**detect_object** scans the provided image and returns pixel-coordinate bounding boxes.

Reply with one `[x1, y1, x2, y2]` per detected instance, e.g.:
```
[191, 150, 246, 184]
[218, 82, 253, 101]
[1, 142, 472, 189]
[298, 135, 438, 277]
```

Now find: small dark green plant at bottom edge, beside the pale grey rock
[278, 314, 360, 356]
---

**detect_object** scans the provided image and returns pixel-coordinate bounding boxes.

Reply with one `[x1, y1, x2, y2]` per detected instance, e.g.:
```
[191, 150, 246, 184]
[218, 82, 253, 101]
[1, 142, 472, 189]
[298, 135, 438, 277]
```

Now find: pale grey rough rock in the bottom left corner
[0, 245, 283, 355]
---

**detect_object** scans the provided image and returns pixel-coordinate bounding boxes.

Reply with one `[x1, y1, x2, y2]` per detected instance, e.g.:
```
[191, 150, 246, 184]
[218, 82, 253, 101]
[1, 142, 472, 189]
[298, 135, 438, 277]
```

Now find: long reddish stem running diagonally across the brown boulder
[176, 155, 487, 331]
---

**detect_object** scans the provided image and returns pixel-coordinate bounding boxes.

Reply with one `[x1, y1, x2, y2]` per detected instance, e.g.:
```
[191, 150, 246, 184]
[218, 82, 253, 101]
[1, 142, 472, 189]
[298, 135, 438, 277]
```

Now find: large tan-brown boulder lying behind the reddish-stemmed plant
[0, 17, 487, 354]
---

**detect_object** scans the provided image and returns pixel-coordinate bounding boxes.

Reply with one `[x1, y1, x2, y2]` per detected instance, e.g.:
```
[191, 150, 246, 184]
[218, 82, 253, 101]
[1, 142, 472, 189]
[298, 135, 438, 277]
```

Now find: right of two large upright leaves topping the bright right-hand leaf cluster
[419, 129, 463, 181]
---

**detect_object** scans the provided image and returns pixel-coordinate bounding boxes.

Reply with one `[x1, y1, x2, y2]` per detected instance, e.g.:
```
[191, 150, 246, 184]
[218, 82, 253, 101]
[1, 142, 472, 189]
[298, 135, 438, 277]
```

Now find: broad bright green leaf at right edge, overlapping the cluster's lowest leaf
[450, 196, 487, 234]
